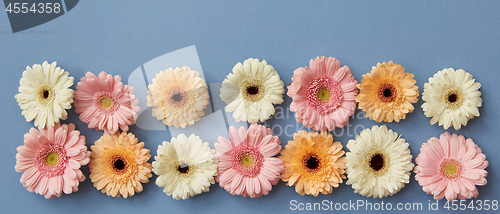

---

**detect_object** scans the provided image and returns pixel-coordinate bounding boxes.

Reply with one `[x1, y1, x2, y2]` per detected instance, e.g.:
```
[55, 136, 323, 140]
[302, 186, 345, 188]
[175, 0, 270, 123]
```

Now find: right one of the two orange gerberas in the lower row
[279, 130, 346, 197]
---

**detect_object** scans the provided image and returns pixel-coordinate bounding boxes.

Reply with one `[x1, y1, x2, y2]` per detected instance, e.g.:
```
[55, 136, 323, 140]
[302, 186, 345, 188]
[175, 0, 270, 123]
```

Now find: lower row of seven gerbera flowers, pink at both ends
[15, 123, 488, 200]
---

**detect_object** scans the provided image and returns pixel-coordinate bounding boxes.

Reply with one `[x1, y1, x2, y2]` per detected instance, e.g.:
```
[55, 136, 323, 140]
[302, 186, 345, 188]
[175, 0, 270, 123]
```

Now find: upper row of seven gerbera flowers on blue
[15, 57, 482, 134]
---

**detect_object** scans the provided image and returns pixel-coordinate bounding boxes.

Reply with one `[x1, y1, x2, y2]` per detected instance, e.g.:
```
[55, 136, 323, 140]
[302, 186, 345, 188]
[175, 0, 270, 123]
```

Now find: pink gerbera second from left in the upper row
[75, 71, 141, 135]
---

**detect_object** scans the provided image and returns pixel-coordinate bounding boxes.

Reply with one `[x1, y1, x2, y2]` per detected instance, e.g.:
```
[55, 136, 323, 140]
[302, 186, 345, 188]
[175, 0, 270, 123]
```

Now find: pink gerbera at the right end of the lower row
[414, 132, 488, 201]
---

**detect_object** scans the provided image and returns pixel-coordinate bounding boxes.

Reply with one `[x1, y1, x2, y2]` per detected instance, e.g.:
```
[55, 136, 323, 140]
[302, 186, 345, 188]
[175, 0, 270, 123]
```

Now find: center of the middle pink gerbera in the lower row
[229, 144, 264, 178]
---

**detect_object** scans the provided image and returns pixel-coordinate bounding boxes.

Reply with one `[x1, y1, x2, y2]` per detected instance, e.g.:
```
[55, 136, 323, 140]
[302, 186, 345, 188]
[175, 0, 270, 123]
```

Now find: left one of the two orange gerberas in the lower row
[89, 132, 152, 198]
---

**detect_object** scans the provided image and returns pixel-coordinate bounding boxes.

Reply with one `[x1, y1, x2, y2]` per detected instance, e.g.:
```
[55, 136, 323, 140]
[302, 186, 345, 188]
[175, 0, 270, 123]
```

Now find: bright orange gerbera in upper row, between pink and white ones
[356, 61, 418, 123]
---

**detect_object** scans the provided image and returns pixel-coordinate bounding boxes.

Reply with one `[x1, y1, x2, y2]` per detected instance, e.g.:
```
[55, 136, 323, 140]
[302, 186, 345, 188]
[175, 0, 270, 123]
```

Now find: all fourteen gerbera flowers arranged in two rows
[15, 57, 488, 200]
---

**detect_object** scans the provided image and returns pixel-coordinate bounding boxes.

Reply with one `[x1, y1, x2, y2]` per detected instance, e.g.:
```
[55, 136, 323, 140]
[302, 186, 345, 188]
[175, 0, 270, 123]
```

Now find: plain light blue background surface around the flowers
[0, 0, 500, 213]
